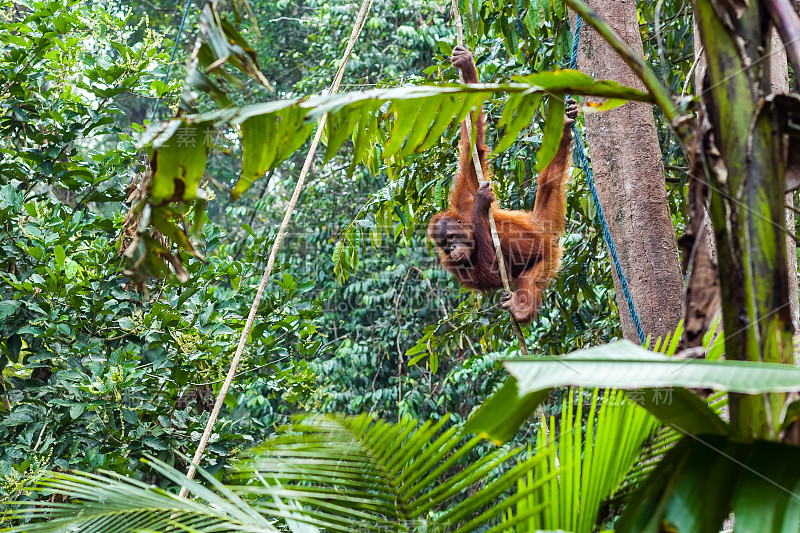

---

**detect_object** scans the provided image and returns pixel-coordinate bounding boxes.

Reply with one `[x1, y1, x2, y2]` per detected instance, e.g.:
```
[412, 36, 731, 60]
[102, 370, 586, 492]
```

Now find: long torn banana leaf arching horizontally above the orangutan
[141, 71, 651, 201]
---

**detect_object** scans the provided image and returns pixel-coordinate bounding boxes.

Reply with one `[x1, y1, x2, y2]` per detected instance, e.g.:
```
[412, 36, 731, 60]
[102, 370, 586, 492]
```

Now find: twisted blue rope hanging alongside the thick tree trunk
[569, 15, 646, 345]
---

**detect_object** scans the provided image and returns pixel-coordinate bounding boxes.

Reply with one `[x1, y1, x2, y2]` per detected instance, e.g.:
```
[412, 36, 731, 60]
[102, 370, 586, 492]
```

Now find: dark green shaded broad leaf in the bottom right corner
[616, 435, 800, 533]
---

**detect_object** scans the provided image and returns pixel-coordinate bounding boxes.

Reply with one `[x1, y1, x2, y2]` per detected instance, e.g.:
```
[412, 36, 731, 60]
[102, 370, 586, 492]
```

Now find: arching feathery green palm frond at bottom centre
[232, 415, 547, 532]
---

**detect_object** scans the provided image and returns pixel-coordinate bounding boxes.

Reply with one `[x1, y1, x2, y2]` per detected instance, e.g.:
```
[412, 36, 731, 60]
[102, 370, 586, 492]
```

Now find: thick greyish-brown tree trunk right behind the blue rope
[578, 0, 683, 342]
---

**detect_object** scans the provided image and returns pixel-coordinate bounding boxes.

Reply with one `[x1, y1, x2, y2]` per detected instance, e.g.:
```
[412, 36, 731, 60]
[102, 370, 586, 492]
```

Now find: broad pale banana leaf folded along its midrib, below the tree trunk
[467, 341, 800, 441]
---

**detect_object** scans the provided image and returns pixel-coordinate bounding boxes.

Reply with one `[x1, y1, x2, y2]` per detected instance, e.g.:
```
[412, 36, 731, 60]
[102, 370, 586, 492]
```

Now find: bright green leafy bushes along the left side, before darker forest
[0, 3, 321, 497]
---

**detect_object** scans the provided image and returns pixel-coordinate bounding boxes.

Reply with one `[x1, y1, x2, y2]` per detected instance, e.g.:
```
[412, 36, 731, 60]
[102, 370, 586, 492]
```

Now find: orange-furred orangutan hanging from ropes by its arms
[428, 47, 577, 322]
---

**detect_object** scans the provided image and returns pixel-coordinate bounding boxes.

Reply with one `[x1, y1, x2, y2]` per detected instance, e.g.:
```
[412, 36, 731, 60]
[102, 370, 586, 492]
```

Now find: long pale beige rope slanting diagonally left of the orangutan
[180, 0, 372, 498]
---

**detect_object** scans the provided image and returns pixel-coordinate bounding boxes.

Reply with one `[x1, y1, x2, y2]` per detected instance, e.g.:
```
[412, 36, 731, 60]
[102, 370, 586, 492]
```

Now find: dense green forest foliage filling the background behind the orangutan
[0, 1, 696, 494]
